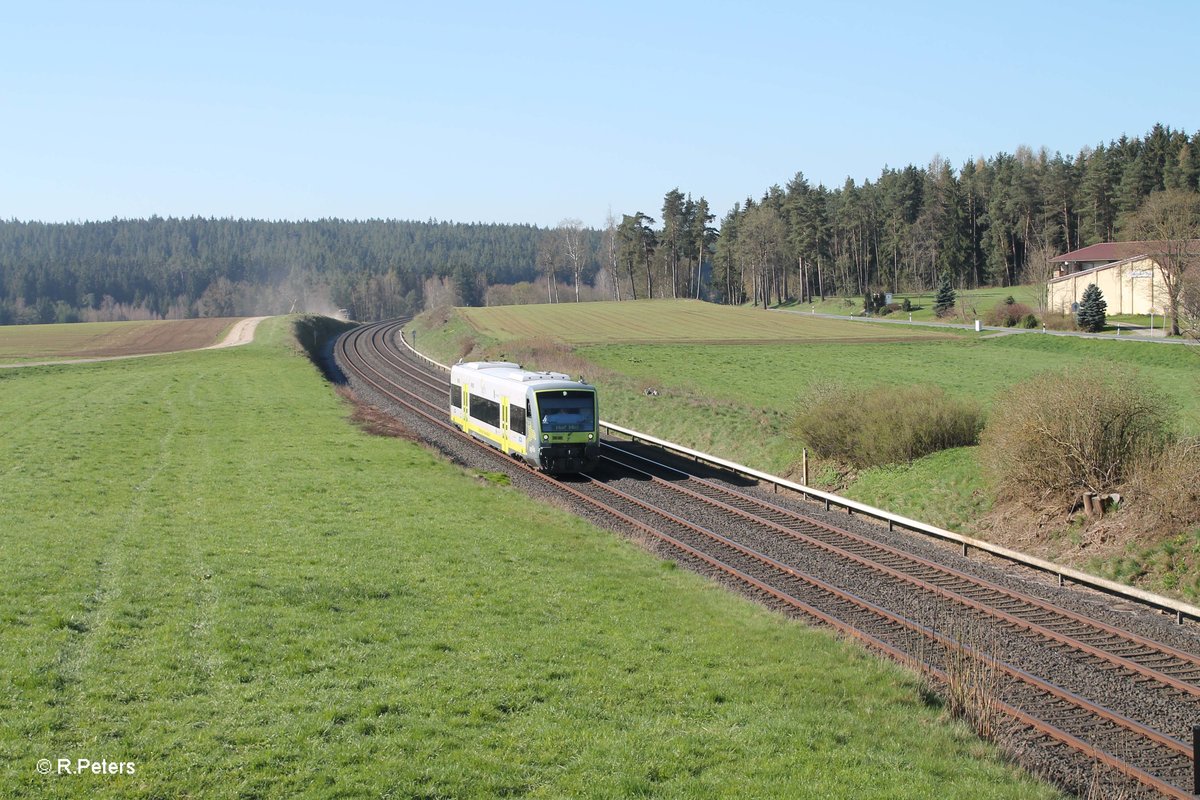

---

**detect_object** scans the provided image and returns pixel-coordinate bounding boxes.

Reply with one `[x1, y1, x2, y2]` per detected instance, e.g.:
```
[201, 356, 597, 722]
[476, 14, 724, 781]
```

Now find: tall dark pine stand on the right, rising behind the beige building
[713, 125, 1200, 305]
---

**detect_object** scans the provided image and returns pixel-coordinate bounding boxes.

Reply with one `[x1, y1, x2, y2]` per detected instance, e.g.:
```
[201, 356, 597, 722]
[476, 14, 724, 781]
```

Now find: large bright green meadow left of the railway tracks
[0, 321, 1049, 798]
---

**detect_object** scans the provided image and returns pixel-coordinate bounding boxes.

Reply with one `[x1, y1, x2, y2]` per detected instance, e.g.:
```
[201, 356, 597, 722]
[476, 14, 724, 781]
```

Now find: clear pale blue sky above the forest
[0, 0, 1200, 227]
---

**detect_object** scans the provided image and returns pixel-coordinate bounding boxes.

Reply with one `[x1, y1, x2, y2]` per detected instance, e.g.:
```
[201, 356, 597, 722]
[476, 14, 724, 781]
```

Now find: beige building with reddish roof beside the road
[1046, 241, 1170, 314]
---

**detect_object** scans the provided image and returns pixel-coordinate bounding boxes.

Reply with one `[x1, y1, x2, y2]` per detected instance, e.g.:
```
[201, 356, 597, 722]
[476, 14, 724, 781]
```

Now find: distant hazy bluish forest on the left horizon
[0, 217, 590, 324]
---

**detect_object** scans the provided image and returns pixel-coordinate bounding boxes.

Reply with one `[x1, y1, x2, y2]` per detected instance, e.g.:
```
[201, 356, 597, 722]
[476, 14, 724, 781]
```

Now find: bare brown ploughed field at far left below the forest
[0, 318, 246, 363]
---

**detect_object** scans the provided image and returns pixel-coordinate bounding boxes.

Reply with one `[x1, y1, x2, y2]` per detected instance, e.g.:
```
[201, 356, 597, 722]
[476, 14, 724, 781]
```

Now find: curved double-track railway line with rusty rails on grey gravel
[335, 321, 1200, 798]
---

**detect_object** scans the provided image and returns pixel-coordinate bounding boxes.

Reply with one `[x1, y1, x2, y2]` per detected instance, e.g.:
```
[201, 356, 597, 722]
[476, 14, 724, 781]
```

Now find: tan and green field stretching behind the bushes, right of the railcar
[436, 301, 1200, 453]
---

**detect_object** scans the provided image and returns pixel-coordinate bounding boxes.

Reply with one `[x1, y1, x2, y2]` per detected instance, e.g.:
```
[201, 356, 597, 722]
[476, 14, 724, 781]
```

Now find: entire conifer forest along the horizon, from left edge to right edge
[0, 125, 1200, 324]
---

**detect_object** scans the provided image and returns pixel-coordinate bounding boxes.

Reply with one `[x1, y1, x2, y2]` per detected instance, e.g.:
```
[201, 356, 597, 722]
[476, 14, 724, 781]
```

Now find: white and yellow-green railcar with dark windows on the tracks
[450, 361, 600, 473]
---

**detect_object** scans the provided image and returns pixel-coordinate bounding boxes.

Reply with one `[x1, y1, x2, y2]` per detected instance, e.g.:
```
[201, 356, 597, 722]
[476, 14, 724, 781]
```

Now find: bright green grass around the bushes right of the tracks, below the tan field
[580, 335, 1200, 522]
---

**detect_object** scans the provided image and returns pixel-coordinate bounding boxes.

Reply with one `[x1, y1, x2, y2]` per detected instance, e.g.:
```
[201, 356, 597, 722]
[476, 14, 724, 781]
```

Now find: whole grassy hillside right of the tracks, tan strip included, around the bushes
[414, 299, 1200, 599]
